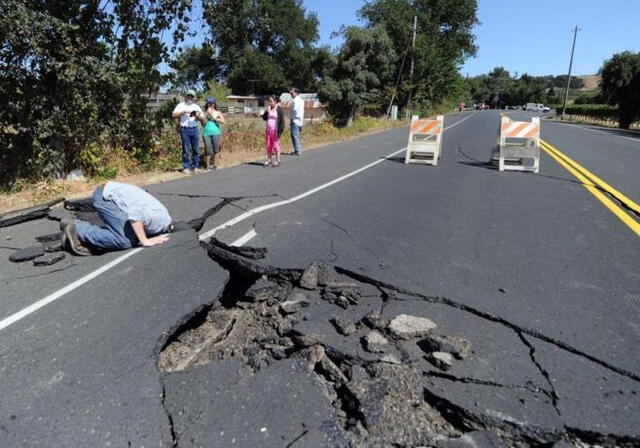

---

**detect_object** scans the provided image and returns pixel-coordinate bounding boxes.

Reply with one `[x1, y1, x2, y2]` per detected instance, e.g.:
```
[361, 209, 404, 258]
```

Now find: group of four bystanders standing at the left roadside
[171, 88, 304, 174]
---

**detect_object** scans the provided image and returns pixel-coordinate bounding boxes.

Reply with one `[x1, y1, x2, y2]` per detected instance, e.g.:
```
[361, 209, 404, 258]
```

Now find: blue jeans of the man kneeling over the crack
[75, 187, 138, 250]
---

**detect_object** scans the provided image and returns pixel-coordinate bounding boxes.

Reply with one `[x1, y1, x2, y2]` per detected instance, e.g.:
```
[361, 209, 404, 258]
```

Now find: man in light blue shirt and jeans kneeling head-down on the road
[60, 182, 172, 255]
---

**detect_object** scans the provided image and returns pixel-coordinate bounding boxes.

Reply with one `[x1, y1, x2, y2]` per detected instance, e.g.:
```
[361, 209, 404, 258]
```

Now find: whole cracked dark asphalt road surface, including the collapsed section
[0, 111, 640, 447]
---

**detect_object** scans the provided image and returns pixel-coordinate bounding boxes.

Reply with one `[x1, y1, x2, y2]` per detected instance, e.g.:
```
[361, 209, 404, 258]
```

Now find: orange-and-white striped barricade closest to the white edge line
[404, 115, 444, 166]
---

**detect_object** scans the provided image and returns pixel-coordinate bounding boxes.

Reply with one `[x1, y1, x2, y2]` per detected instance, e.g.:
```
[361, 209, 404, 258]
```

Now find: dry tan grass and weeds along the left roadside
[0, 117, 404, 212]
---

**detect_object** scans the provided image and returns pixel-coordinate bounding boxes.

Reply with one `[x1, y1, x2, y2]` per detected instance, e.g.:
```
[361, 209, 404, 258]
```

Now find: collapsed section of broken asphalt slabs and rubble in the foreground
[158, 242, 640, 447]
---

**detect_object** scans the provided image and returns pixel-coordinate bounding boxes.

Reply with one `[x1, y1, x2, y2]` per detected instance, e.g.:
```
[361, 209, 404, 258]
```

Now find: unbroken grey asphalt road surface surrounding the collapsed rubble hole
[0, 111, 640, 446]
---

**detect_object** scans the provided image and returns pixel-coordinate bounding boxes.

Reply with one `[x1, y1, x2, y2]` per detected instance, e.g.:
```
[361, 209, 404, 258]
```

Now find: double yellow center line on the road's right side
[540, 140, 640, 236]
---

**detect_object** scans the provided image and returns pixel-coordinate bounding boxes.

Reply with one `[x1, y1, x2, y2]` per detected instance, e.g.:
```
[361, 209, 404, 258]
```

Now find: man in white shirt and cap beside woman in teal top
[171, 90, 204, 174]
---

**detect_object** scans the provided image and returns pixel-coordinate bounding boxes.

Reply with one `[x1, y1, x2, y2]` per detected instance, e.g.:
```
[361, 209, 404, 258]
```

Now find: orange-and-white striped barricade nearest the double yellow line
[491, 117, 540, 173]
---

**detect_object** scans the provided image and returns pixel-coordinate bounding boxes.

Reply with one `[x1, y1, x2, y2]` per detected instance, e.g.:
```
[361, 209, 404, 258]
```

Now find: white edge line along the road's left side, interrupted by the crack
[0, 113, 475, 331]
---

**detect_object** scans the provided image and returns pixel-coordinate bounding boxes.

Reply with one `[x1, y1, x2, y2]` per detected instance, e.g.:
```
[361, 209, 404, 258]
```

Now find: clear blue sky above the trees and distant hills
[304, 0, 640, 76]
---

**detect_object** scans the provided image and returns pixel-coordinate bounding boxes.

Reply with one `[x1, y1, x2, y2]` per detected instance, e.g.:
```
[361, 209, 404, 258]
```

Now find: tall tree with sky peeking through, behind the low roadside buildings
[204, 0, 320, 93]
